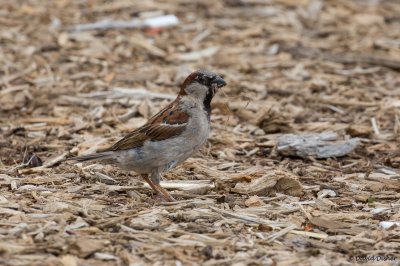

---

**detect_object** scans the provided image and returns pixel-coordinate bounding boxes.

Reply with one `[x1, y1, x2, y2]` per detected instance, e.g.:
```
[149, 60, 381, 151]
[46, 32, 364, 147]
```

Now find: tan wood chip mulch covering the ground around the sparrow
[0, 0, 400, 266]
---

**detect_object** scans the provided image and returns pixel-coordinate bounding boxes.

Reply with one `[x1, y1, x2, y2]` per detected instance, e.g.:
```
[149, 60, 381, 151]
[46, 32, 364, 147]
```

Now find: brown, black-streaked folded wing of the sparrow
[109, 99, 189, 151]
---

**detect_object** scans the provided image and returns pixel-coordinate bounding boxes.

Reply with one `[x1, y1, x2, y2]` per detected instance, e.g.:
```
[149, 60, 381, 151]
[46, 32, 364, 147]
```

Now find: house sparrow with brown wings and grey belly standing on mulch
[68, 70, 226, 201]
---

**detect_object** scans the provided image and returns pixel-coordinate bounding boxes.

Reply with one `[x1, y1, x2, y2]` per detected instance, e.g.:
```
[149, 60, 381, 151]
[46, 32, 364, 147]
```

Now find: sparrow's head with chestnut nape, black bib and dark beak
[179, 70, 226, 111]
